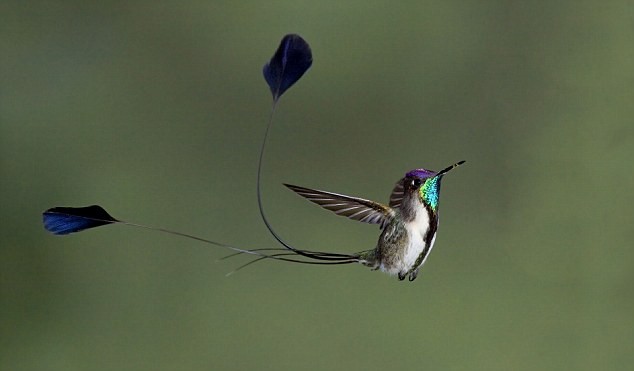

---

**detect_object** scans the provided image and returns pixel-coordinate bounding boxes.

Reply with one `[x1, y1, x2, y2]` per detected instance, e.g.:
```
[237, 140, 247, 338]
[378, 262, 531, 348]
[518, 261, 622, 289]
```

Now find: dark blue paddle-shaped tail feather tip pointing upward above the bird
[262, 34, 313, 101]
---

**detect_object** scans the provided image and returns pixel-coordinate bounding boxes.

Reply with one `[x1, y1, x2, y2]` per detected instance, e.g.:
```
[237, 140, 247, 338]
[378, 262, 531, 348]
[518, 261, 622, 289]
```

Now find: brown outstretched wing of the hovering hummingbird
[284, 184, 394, 228]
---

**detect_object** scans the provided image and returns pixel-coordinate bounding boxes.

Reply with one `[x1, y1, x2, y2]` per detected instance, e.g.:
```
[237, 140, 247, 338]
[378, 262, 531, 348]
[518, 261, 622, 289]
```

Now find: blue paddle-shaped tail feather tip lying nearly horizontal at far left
[42, 205, 118, 235]
